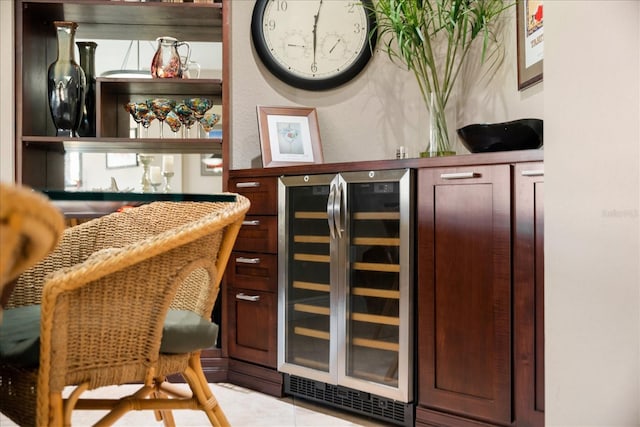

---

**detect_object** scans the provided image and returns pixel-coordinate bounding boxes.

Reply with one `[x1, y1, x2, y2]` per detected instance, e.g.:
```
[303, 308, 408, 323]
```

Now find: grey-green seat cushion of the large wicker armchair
[0, 305, 218, 367]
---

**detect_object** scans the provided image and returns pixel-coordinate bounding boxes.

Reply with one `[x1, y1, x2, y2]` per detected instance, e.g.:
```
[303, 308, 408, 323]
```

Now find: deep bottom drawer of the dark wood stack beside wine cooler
[227, 288, 278, 368]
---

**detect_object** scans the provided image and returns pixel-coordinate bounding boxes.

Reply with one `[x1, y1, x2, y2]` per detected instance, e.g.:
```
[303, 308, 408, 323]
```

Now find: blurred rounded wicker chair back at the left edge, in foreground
[0, 183, 64, 323]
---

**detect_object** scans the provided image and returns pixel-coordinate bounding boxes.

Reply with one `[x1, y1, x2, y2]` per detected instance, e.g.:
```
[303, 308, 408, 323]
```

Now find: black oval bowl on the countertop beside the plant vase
[458, 119, 543, 153]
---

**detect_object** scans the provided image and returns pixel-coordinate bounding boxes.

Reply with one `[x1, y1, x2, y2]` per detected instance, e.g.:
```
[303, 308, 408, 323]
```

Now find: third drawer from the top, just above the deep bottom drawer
[227, 252, 278, 292]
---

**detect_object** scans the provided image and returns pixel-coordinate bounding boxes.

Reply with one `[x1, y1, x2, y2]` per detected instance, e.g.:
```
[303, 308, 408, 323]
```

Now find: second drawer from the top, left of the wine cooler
[234, 216, 278, 254]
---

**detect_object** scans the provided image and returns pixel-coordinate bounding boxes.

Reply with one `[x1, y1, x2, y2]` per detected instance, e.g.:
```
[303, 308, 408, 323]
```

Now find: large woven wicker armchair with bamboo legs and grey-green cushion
[0, 195, 249, 426]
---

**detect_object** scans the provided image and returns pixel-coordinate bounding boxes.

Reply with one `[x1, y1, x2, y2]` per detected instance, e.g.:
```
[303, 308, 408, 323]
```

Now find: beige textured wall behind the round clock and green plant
[231, 1, 544, 169]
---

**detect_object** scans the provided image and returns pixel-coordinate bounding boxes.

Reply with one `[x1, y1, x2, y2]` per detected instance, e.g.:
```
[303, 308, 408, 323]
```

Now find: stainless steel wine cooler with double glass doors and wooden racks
[278, 169, 414, 425]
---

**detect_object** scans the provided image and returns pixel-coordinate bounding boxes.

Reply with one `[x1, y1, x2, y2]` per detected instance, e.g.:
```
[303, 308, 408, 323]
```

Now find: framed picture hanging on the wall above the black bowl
[516, 0, 544, 90]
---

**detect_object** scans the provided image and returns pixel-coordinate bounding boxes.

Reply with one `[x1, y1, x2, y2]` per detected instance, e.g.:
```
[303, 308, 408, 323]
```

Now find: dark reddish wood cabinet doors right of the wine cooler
[416, 162, 544, 426]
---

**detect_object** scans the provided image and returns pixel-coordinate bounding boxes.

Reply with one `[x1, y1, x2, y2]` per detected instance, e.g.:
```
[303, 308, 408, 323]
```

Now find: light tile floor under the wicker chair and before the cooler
[0, 383, 388, 427]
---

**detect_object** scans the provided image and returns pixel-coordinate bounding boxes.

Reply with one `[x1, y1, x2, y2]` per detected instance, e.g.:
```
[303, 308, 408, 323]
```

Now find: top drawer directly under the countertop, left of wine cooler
[229, 177, 278, 215]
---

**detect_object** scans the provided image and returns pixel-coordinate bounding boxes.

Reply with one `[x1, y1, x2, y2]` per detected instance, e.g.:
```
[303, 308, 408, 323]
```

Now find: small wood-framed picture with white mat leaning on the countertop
[258, 106, 323, 167]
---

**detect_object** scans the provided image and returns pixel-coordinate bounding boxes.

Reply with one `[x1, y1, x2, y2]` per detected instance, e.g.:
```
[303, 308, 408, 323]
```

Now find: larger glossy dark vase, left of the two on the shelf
[47, 21, 86, 137]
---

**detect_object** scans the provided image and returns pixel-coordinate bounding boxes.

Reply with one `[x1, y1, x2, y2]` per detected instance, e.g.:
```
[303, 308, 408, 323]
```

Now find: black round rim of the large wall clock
[251, 0, 378, 91]
